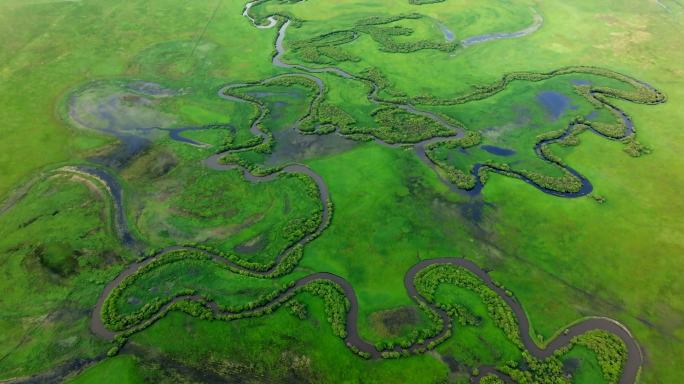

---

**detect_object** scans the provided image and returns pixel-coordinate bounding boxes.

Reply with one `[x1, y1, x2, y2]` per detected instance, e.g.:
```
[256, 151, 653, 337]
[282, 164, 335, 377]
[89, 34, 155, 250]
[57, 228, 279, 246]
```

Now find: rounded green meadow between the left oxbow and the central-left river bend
[125, 162, 322, 264]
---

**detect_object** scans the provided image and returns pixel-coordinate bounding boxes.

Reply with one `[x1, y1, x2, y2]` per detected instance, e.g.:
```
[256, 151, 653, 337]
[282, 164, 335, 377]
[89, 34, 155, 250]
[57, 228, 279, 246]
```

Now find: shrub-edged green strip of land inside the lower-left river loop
[102, 251, 350, 352]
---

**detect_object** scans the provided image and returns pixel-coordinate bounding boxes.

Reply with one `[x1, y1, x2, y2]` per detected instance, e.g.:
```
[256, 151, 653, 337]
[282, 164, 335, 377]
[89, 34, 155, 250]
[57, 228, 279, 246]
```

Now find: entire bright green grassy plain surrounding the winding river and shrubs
[0, 0, 684, 383]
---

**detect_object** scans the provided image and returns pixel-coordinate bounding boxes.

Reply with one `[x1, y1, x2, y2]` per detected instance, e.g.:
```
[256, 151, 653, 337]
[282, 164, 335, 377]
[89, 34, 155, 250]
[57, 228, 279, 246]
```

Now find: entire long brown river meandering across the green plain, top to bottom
[81, 2, 656, 384]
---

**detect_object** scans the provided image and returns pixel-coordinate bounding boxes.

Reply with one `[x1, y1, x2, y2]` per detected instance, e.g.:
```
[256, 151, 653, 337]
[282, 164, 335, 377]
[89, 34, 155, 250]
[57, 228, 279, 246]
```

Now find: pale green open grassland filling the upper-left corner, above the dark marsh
[0, 1, 274, 195]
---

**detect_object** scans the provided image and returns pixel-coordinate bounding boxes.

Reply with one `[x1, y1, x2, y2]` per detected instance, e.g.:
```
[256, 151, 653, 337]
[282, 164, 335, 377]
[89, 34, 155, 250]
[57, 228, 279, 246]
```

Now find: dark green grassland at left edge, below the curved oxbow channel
[0, 173, 125, 377]
